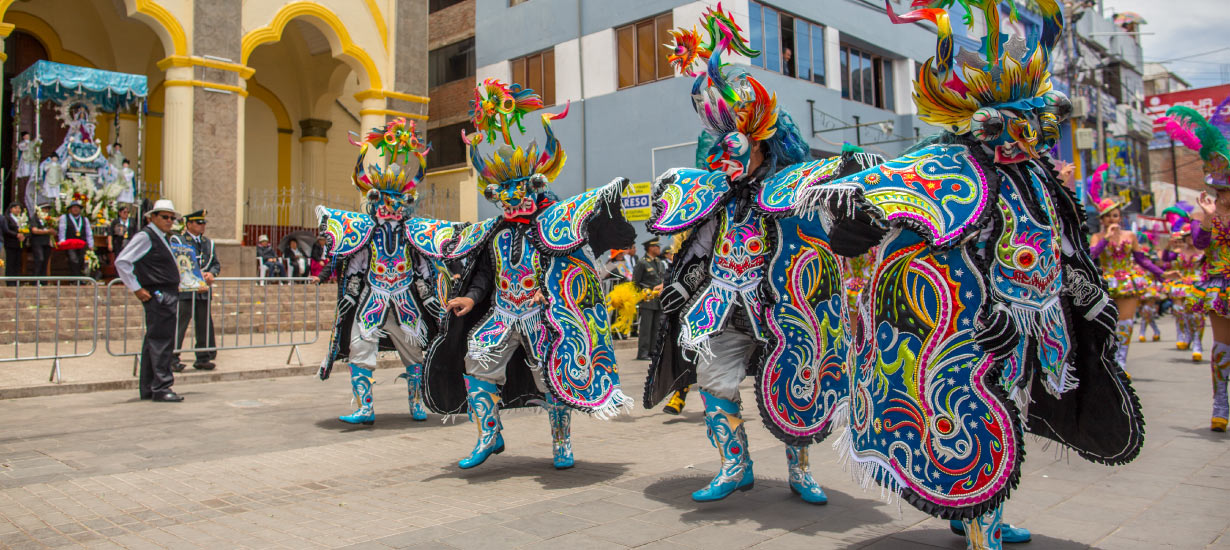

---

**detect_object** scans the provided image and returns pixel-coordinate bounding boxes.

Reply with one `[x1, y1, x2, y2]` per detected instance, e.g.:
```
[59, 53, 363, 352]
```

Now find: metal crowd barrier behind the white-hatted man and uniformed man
[106, 277, 331, 377]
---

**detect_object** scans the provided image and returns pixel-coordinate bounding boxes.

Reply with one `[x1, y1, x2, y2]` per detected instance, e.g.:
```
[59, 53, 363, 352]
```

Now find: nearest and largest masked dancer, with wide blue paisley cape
[797, 0, 1144, 550]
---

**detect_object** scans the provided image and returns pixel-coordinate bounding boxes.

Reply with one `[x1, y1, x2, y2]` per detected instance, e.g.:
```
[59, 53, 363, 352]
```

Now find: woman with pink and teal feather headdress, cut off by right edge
[1159, 100, 1230, 432]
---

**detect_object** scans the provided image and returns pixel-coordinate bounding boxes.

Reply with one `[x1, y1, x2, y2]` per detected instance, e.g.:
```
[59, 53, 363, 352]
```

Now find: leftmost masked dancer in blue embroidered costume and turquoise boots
[316, 118, 453, 424]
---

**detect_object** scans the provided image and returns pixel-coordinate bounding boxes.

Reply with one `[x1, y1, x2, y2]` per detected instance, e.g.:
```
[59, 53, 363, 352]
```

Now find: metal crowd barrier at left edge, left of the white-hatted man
[0, 277, 98, 383]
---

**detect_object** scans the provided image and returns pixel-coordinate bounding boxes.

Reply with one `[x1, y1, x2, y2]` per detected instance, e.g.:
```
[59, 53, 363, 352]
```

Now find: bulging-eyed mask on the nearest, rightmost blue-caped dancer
[969, 91, 1071, 164]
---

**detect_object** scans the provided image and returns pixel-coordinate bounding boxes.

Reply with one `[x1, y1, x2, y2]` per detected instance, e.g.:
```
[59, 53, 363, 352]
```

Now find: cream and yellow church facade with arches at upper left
[0, 0, 477, 271]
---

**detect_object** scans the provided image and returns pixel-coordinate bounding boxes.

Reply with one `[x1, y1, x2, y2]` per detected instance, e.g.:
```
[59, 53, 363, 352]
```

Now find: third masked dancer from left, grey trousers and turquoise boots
[645, 6, 885, 504]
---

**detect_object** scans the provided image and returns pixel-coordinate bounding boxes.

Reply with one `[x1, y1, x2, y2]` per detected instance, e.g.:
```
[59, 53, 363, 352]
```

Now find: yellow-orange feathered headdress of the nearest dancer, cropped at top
[884, 0, 1066, 134]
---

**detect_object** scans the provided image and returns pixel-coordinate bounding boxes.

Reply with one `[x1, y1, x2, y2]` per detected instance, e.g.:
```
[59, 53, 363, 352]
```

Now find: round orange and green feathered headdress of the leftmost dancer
[351, 118, 431, 199]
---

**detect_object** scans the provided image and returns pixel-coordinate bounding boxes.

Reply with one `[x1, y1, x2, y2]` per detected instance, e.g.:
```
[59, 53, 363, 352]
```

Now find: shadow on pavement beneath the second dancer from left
[423, 449, 629, 491]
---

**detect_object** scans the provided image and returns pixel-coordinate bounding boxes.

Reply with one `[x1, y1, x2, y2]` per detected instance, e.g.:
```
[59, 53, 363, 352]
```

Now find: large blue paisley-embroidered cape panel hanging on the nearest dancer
[840, 241, 1021, 508]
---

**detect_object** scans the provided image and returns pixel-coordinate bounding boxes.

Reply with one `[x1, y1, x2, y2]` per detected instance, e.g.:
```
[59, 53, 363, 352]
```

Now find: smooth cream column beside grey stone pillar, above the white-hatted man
[161, 66, 196, 212]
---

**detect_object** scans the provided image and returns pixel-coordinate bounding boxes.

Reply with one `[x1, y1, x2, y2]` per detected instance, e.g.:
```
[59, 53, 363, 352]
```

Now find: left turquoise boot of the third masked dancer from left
[692, 390, 755, 502]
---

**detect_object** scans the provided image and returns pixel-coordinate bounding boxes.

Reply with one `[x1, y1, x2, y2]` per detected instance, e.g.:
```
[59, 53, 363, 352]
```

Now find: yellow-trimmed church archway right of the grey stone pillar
[244, 15, 369, 244]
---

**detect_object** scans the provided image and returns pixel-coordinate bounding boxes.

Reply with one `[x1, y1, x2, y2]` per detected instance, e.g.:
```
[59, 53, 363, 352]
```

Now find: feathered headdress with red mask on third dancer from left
[665, 2, 808, 177]
